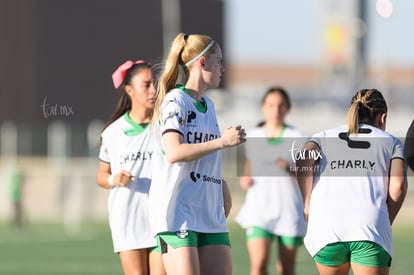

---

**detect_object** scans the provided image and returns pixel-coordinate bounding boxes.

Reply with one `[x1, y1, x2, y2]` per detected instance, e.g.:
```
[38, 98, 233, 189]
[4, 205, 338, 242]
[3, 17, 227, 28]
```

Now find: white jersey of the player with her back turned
[304, 124, 403, 256]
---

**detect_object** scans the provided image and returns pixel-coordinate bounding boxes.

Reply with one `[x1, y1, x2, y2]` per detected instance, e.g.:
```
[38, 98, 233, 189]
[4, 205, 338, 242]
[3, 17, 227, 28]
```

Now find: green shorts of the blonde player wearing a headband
[156, 230, 230, 253]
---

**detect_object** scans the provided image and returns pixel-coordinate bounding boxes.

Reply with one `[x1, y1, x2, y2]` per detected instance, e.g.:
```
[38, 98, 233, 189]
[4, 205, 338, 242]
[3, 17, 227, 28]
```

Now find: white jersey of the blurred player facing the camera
[236, 126, 306, 237]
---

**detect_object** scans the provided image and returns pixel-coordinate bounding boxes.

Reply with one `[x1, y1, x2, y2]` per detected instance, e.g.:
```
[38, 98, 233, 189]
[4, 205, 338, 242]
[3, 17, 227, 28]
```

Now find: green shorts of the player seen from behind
[313, 241, 391, 267]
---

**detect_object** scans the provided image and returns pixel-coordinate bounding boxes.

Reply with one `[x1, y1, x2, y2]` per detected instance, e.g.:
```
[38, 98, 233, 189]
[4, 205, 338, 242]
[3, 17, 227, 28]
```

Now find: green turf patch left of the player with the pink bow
[0, 224, 122, 275]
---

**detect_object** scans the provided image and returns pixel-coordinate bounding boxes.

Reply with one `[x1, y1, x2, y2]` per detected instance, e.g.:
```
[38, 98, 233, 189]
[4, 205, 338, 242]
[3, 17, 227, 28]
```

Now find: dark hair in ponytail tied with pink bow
[99, 60, 152, 145]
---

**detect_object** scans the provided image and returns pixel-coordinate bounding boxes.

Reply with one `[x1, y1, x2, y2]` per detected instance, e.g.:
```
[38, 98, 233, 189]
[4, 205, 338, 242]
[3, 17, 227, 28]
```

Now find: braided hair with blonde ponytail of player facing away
[347, 89, 388, 134]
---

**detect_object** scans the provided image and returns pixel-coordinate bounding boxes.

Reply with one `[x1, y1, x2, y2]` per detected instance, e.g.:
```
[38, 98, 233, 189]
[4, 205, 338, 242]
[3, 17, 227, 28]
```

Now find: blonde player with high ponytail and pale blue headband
[149, 33, 245, 275]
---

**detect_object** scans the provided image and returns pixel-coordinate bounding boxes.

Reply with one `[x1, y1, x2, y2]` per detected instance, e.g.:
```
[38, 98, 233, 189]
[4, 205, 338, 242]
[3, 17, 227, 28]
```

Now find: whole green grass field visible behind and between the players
[0, 222, 414, 275]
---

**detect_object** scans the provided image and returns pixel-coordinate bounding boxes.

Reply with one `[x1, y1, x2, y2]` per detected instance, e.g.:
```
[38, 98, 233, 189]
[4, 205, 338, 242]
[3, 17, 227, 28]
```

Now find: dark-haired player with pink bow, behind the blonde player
[97, 60, 164, 275]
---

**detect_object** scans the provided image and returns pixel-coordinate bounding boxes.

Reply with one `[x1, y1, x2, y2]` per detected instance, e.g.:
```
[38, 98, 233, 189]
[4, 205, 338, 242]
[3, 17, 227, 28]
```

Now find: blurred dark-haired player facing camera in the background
[236, 87, 306, 275]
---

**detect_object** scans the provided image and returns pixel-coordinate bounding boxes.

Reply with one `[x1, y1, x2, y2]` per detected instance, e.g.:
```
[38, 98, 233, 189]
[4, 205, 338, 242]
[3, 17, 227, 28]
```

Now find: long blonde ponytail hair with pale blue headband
[152, 33, 216, 122]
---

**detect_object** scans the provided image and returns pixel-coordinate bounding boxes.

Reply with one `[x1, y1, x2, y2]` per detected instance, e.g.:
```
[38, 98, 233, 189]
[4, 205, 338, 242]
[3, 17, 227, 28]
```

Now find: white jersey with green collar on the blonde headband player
[149, 89, 228, 234]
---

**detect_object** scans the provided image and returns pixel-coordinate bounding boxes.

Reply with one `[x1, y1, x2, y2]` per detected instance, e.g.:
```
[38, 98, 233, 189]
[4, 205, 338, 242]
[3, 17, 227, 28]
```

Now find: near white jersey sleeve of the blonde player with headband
[160, 97, 186, 135]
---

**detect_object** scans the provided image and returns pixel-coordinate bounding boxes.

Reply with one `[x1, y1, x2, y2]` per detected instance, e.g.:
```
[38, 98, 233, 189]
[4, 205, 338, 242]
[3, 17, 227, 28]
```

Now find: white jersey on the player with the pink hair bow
[99, 114, 156, 252]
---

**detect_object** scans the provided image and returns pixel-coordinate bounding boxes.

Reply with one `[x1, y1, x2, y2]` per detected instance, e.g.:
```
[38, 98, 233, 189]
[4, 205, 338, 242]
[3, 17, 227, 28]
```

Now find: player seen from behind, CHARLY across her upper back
[297, 89, 407, 275]
